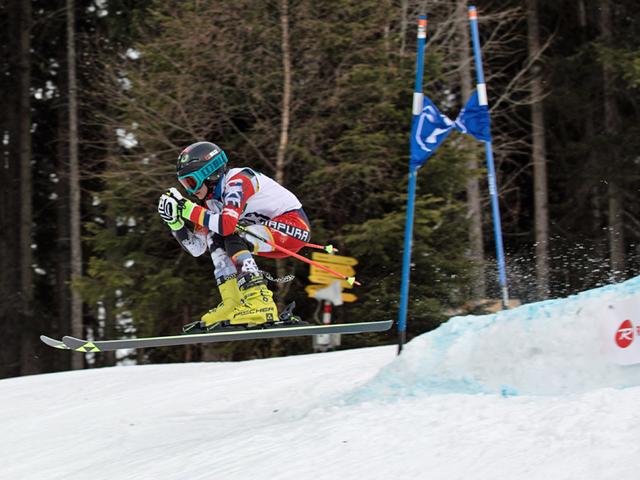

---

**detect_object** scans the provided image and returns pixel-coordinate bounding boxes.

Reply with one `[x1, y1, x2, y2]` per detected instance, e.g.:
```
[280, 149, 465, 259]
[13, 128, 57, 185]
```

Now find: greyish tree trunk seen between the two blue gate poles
[456, 0, 486, 299]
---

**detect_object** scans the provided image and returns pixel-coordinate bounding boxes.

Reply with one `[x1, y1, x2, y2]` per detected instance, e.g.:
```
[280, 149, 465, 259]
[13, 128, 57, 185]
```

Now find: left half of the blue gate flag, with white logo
[411, 96, 455, 169]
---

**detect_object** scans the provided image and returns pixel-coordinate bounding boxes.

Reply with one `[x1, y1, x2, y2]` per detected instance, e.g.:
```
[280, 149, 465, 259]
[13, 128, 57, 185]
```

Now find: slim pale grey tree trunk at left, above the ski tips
[67, 0, 84, 369]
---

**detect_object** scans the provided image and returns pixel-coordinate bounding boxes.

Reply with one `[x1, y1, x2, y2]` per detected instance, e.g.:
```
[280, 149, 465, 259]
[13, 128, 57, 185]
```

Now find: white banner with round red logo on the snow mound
[599, 295, 640, 365]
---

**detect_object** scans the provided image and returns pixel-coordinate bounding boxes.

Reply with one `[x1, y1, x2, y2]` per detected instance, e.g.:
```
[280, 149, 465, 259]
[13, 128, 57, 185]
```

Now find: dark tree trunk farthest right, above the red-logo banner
[600, 0, 625, 281]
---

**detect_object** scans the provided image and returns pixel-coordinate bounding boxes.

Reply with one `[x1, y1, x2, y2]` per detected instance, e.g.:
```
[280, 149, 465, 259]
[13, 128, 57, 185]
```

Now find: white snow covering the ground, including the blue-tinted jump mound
[0, 279, 640, 480]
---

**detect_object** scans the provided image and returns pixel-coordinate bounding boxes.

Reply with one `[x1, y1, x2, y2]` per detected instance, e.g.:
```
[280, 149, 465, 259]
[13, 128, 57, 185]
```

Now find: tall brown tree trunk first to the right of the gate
[527, 0, 549, 300]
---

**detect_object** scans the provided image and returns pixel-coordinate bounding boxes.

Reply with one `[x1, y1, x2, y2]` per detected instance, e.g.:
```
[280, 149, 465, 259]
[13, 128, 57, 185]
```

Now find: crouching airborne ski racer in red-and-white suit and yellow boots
[158, 142, 310, 333]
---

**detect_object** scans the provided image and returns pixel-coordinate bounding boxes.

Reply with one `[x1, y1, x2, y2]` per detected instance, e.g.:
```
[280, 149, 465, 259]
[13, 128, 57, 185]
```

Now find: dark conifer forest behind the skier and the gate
[0, 0, 640, 377]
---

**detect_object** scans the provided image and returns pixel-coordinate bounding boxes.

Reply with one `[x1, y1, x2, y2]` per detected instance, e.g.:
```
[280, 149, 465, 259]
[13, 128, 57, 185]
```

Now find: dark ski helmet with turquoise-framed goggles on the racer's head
[176, 142, 228, 193]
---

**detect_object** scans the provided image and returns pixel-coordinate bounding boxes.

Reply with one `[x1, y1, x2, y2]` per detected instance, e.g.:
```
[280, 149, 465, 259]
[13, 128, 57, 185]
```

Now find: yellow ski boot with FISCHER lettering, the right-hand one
[229, 274, 278, 328]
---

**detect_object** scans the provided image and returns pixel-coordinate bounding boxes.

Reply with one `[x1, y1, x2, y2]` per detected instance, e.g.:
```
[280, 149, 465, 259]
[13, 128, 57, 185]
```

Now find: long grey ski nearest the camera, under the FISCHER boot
[57, 320, 393, 353]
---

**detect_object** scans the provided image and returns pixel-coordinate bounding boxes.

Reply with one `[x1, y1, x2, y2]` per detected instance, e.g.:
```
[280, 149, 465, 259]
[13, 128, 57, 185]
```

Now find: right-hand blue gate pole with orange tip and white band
[469, 6, 509, 308]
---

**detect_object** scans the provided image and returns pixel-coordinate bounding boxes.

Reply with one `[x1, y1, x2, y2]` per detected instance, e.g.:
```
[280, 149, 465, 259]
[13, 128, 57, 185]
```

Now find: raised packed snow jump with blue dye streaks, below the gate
[350, 277, 640, 401]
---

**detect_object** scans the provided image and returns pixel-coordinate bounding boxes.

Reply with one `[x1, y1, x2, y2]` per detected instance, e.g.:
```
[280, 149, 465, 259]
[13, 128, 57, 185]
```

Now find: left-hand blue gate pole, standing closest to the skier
[398, 15, 427, 355]
